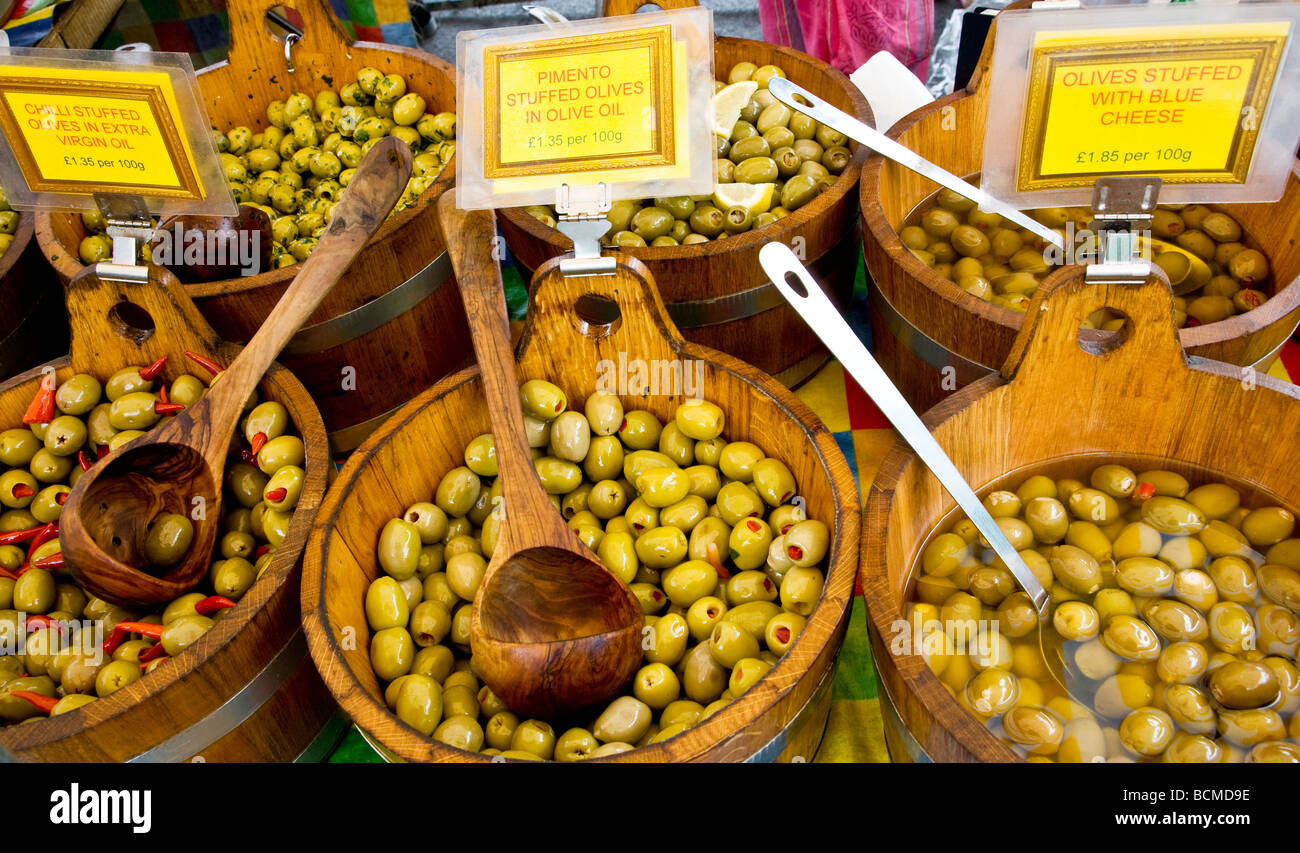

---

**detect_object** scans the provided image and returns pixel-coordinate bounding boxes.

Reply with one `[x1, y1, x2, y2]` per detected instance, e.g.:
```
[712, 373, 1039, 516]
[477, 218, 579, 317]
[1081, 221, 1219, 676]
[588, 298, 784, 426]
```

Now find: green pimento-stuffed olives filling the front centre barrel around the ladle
[365, 380, 829, 761]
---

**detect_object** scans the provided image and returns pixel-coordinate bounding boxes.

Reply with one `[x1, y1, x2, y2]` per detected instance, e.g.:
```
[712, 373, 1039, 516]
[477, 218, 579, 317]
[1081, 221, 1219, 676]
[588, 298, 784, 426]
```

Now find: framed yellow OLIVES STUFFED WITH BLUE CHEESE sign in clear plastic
[980, 3, 1300, 207]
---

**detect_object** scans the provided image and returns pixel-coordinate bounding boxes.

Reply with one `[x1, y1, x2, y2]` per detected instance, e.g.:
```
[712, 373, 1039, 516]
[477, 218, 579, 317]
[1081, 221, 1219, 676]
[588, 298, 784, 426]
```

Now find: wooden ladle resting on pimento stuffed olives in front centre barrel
[438, 192, 645, 719]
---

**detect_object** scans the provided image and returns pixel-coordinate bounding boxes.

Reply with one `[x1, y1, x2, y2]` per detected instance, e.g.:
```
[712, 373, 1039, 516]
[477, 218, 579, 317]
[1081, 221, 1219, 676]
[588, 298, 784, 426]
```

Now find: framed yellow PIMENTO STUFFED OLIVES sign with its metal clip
[456, 8, 714, 274]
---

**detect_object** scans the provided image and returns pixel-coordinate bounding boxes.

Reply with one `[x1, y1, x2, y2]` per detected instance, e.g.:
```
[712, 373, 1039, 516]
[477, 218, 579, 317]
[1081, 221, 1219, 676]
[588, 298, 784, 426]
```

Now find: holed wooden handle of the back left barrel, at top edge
[226, 0, 352, 74]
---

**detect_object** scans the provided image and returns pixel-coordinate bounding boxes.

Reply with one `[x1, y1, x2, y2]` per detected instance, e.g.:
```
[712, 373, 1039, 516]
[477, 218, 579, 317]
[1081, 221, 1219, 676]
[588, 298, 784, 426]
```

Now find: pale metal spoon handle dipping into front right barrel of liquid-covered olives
[758, 241, 1048, 615]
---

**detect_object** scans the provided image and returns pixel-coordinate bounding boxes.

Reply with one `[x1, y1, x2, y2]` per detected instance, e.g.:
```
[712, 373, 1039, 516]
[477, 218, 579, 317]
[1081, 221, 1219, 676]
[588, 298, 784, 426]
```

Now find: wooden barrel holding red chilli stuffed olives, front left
[0, 268, 338, 762]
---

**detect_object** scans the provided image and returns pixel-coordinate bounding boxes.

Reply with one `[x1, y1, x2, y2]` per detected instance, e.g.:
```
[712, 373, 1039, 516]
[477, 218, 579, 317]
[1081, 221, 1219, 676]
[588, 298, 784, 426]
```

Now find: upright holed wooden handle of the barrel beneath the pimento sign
[516, 257, 684, 376]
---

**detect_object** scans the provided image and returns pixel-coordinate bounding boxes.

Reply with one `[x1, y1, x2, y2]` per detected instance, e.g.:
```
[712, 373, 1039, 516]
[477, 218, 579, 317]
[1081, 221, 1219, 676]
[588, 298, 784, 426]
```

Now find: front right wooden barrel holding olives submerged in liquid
[862, 267, 1300, 761]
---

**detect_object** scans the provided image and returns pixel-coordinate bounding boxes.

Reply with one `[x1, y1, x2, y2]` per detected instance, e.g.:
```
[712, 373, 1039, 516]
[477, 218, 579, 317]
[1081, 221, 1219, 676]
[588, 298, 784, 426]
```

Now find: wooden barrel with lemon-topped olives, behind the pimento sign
[498, 0, 872, 387]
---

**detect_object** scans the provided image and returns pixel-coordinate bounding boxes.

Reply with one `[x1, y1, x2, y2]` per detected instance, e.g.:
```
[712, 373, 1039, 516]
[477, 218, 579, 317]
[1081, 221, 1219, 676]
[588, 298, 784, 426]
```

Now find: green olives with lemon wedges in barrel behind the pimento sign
[524, 62, 853, 247]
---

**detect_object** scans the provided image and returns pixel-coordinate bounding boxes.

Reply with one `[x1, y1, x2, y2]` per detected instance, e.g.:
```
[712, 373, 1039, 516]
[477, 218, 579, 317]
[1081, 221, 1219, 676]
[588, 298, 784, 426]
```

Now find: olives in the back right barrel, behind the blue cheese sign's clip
[898, 189, 1270, 323]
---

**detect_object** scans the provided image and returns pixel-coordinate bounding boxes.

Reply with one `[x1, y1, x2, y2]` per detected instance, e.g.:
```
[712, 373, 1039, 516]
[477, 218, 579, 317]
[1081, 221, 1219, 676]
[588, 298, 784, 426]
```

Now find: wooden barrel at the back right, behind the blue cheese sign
[861, 11, 1300, 410]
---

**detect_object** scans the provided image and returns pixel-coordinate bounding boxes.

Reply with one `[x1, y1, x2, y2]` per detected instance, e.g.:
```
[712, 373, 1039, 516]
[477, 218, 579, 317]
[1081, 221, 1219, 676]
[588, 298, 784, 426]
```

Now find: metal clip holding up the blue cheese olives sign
[1084, 177, 1164, 285]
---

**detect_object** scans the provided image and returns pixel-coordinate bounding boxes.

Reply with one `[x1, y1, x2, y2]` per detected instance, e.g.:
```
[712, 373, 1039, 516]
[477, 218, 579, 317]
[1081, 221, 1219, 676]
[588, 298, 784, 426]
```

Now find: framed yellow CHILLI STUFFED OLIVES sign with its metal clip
[0, 48, 237, 281]
